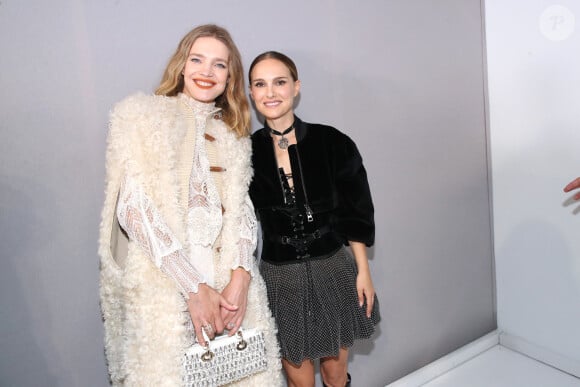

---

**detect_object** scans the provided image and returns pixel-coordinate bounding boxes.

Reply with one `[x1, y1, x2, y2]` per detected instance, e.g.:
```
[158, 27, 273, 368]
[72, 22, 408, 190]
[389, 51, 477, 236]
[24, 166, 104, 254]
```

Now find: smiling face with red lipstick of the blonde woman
[182, 37, 229, 102]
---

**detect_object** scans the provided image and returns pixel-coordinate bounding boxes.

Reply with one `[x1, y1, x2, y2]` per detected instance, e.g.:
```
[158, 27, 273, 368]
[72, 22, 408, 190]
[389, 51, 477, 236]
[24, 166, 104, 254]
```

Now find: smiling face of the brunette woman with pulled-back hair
[250, 58, 300, 129]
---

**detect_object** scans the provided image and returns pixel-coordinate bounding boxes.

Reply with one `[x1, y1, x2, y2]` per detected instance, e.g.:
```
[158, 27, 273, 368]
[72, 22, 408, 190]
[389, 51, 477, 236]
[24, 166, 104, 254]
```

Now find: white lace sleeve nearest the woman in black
[232, 196, 258, 277]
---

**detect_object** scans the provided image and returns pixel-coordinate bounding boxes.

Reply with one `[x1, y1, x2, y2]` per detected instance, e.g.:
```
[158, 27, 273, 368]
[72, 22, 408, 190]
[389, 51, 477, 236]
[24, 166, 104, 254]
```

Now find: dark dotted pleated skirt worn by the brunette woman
[260, 247, 380, 364]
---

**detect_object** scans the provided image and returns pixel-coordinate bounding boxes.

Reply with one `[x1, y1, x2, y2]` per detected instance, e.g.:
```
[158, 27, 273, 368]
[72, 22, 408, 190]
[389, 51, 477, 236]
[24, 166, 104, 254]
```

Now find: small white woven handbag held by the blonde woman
[183, 328, 268, 387]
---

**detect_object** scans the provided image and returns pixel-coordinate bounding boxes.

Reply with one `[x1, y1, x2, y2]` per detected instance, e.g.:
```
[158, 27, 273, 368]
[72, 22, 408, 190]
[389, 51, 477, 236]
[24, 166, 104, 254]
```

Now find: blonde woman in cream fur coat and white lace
[100, 25, 282, 386]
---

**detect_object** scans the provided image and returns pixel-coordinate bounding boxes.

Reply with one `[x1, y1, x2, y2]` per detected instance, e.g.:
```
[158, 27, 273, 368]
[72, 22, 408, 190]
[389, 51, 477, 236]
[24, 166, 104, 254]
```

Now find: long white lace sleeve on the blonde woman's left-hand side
[117, 177, 206, 298]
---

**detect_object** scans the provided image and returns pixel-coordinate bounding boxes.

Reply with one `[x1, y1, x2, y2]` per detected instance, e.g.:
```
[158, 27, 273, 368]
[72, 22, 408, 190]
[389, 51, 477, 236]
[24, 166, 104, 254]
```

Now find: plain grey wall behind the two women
[0, 0, 495, 386]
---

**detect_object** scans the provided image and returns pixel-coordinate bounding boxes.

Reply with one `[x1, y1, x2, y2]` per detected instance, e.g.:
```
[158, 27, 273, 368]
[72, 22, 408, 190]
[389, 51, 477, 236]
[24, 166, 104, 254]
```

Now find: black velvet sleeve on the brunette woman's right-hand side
[334, 134, 375, 246]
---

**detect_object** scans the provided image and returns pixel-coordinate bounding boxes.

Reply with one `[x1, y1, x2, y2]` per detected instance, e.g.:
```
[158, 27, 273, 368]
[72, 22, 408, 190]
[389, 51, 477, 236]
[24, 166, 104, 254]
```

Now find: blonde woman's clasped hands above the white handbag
[187, 268, 251, 346]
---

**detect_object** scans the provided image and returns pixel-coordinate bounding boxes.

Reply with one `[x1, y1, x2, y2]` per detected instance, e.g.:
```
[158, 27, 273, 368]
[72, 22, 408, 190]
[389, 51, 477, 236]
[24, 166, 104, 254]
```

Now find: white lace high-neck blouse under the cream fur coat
[117, 94, 257, 298]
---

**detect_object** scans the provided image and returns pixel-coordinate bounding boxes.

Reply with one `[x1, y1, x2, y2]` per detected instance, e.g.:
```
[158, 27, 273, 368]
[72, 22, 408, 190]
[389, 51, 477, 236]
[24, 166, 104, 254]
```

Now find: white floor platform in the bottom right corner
[422, 345, 580, 387]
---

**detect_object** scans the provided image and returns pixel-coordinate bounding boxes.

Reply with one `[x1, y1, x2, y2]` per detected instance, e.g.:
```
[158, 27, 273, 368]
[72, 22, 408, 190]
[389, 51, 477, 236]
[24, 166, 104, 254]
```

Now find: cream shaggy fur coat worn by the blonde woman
[99, 94, 283, 386]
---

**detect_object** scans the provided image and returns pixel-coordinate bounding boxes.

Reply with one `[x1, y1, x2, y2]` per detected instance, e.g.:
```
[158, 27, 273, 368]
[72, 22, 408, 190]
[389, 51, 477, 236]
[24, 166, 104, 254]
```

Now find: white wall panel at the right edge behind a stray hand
[485, 0, 580, 376]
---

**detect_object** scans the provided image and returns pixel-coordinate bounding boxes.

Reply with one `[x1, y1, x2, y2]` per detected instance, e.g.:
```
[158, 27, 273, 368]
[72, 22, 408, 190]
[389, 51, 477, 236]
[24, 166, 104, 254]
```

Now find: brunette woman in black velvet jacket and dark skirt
[249, 51, 380, 387]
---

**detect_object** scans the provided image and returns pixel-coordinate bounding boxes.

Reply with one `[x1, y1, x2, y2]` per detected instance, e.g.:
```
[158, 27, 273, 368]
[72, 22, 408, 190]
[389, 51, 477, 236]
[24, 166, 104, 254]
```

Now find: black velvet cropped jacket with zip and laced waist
[250, 116, 375, 263]
